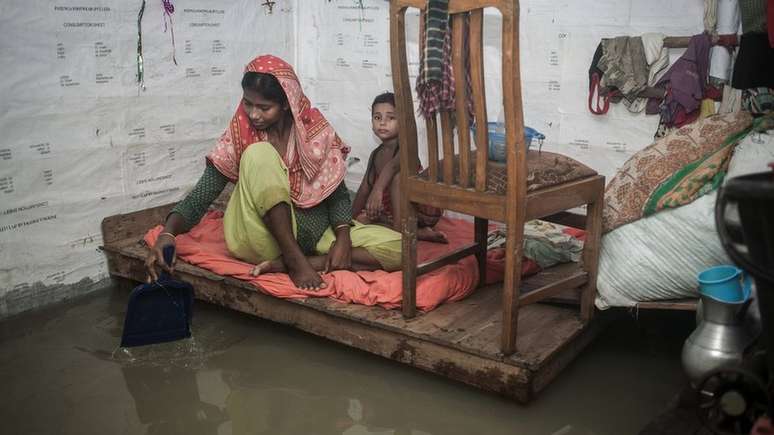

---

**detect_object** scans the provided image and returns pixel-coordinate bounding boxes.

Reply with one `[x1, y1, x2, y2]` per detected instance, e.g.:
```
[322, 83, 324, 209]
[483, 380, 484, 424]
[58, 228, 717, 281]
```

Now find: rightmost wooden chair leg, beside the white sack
[581, 178, 605, 322]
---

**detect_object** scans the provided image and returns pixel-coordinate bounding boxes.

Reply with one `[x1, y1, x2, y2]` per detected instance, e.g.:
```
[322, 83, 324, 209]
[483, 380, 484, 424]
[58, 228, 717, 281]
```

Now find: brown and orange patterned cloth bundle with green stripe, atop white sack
[603, 112, 752, 232]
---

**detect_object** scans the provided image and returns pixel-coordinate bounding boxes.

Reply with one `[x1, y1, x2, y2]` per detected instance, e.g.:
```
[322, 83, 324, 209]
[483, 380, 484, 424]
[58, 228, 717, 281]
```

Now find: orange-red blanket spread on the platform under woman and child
[145, 211, 539, 311]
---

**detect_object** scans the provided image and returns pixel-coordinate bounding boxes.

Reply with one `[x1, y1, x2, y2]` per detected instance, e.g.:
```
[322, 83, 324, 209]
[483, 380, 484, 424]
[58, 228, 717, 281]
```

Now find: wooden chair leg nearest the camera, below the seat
[501, 221, 524, 355]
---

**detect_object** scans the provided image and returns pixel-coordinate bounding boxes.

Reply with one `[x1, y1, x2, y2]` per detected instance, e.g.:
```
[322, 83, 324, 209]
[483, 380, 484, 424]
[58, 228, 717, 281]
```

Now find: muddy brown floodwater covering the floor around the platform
[0, 289, 690, 435]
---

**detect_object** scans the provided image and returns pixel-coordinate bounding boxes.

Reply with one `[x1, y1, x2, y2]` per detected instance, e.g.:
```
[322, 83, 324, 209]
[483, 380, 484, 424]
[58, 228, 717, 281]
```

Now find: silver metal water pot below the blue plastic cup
[682, 295, 755, 386]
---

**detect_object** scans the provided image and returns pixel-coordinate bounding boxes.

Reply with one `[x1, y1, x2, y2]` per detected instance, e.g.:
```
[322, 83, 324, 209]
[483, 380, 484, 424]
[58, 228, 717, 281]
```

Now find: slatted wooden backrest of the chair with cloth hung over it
[390, 0, 526, 215]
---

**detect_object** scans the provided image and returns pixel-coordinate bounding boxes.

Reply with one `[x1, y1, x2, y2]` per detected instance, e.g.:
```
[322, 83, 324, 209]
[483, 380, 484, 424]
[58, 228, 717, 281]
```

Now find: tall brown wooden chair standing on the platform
[390, 0, 605, 355]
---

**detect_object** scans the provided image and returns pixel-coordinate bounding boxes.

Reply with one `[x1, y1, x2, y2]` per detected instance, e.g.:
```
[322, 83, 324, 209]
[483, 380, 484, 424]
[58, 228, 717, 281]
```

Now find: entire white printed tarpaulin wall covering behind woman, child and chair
[0, 0, 703, 317]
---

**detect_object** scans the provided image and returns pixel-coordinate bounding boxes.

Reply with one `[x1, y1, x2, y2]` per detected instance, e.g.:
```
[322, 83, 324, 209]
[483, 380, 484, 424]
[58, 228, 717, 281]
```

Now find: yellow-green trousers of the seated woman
[223, 142, 401, 271]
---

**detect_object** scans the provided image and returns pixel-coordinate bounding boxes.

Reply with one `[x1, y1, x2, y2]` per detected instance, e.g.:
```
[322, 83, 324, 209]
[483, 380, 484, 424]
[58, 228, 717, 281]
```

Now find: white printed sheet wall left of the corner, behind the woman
[0, 0, 295, 317]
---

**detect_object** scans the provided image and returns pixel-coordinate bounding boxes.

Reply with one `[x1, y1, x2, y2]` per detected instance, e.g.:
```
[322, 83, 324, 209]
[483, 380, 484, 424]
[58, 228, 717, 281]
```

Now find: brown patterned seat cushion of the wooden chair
[419, 150, 597, 194]
